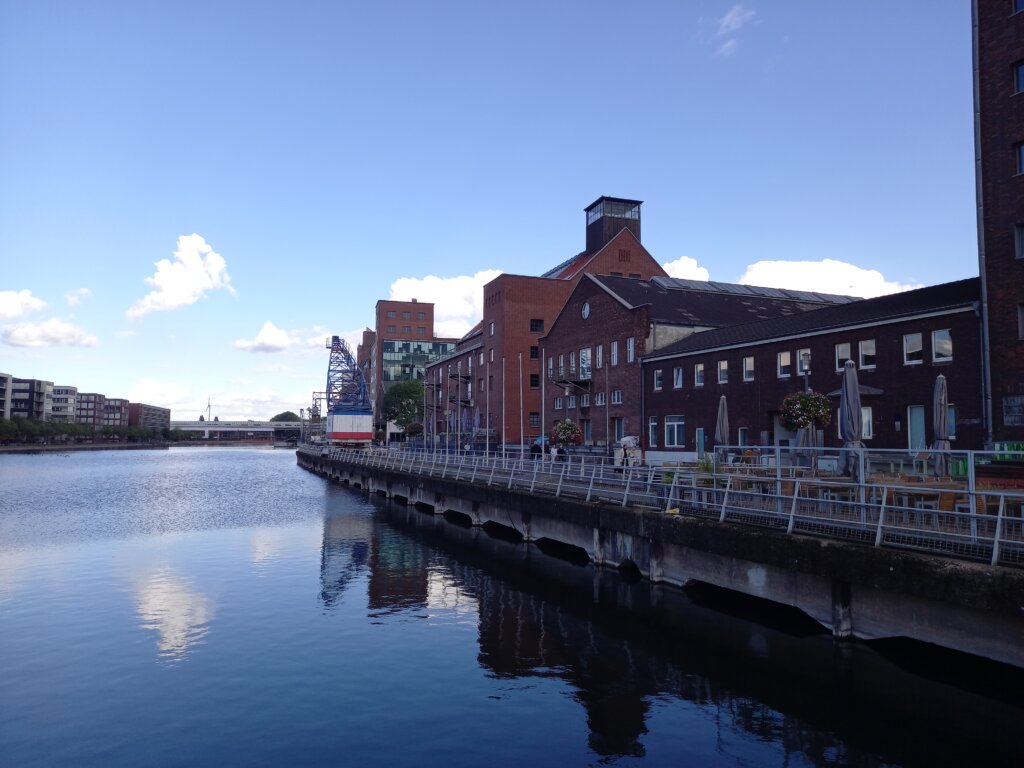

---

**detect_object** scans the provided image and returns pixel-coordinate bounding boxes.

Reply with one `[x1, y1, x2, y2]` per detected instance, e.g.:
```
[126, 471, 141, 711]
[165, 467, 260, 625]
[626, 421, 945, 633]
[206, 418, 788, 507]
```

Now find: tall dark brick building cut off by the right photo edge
[973, 0, 1024, 442]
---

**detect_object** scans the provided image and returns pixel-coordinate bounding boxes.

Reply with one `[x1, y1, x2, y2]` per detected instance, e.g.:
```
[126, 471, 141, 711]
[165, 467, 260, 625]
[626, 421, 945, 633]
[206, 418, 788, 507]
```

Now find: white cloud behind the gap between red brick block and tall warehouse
[387, 269, 502, 340]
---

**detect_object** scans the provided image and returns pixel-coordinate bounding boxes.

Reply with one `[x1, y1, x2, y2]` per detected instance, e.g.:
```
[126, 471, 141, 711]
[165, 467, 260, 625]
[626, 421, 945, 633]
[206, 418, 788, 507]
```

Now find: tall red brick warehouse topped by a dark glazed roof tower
[427, 197, 666, 443]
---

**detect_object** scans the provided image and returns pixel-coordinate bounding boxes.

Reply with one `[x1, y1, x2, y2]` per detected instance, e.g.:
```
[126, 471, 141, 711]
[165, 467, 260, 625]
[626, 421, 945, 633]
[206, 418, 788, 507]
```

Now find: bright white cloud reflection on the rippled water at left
[135, 568, 215, 662]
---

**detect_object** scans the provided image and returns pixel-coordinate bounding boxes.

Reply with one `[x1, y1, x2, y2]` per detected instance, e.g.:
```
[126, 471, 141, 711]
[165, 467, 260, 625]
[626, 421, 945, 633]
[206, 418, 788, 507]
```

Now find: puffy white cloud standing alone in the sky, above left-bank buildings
[126, 234, 234, 319]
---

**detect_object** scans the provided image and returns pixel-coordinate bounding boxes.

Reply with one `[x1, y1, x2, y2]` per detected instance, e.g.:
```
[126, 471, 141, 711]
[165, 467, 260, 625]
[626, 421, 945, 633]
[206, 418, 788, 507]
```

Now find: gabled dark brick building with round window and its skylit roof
[541, 273, 854, 445]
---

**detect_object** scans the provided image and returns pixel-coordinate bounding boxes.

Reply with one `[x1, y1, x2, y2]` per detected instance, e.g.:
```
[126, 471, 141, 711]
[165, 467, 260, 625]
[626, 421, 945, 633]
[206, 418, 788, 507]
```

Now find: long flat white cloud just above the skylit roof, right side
[738, 259, 922, 299]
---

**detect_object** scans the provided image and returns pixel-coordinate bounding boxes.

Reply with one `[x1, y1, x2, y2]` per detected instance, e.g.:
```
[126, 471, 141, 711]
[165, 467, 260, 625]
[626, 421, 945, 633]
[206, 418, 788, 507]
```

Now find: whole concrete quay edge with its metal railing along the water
[297, 446, 1024, 667]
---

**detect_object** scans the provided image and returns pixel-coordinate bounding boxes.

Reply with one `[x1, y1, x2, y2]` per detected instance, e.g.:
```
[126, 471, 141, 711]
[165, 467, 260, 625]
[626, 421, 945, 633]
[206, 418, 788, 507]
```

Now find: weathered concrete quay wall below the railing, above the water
[298, 453, 1024, 668]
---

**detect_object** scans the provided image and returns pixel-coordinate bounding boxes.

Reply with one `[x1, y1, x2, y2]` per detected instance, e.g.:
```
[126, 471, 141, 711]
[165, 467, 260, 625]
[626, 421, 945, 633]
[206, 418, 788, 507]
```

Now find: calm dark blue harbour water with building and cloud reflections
[0, 449, 1024, 768]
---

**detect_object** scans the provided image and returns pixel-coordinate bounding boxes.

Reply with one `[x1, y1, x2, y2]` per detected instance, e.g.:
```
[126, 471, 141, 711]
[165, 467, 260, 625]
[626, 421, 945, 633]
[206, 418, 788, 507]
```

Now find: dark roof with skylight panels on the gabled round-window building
[587, 274, 853, 328]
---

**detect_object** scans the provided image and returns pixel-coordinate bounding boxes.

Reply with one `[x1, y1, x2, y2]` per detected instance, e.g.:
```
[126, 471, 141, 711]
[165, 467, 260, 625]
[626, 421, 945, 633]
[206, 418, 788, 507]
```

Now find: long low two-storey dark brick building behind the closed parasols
[642, 278, 984, 462]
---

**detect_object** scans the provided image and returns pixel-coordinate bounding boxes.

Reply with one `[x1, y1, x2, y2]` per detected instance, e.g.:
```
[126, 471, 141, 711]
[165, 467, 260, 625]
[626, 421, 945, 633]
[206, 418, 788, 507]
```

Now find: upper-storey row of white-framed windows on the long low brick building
[654, 331, 954, 391]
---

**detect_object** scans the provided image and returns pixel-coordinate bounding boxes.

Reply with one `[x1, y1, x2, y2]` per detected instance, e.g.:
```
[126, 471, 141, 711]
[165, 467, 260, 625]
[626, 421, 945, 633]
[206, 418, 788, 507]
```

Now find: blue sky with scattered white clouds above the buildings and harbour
[0, 0, 978, 419]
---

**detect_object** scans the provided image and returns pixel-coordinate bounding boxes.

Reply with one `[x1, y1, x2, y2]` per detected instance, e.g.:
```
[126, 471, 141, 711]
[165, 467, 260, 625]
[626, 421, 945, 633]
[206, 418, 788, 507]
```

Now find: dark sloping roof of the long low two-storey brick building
[649, 278, 981, 359]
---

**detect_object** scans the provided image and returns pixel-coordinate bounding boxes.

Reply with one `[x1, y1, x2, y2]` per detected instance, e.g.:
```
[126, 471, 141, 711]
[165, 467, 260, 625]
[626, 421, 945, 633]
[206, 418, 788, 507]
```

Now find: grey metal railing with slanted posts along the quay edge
[299, 445, 1024, 567]
